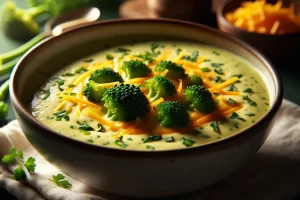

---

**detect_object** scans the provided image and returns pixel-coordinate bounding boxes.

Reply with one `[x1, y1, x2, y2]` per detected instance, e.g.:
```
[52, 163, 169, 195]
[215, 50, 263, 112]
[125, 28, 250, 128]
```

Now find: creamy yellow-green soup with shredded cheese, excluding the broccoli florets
[32, 42, 270, 151]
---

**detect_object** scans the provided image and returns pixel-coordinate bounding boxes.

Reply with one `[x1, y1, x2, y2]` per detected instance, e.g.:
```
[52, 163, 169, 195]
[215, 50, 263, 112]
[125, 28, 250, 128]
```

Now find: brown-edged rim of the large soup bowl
[9, 18, 283, 157]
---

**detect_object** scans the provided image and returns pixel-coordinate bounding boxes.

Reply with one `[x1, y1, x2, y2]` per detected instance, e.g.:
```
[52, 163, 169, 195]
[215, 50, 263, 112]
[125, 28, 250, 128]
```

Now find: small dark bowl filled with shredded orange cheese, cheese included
[217, 0, 300, 60]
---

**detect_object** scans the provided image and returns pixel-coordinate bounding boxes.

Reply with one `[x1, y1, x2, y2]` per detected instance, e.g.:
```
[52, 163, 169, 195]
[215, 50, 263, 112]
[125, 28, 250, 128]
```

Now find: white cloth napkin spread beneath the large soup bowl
[0, 100, 300, 200]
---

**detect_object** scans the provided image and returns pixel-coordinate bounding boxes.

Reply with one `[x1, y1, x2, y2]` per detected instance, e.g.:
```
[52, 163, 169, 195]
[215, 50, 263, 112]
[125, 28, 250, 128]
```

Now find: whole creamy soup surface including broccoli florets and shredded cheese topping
[32, 42, 270, 151]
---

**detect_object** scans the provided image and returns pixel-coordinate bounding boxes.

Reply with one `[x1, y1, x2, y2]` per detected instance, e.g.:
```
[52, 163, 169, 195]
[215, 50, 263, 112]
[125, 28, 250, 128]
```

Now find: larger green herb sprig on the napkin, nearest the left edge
[1, 147, 36, 181]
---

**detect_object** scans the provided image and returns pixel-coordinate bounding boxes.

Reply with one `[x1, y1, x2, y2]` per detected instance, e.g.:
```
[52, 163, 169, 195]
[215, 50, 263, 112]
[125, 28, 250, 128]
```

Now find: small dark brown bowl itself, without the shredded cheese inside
[217, 0, 300, 61]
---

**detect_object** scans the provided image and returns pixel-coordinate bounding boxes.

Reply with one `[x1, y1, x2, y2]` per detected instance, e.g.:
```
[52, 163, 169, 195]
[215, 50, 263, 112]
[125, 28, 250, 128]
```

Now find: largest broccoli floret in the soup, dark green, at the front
[103, 83, 149, 121]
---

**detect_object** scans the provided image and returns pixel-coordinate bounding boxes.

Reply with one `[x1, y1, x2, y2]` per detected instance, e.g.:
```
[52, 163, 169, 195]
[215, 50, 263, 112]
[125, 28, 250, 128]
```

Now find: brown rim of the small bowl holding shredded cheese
[216, 0, 300, 38]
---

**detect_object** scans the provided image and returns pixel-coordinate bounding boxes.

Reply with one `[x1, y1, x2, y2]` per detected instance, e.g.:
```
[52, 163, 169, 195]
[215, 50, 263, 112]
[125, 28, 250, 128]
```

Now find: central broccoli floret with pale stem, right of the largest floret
[145, 76, 176, 102]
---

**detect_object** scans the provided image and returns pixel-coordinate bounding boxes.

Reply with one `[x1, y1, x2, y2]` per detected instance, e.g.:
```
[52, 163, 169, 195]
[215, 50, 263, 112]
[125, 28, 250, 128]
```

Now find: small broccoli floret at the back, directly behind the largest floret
[122, 60, 151, 79]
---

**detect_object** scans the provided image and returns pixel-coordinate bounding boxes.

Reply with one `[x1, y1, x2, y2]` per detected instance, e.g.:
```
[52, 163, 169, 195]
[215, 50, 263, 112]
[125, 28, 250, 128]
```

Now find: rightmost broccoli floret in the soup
[183, 85, 216, 113]
